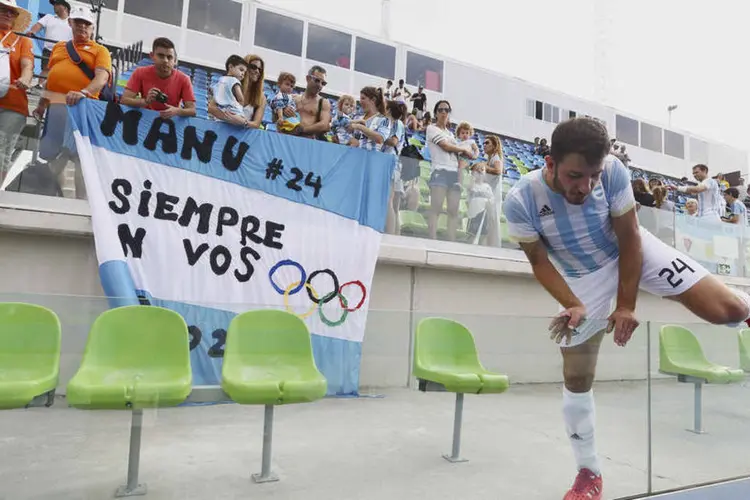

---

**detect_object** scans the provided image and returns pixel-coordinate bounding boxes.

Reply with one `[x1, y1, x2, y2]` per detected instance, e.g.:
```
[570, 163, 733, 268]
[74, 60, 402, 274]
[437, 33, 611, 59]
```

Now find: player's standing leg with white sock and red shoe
[560, 332, 604, 500]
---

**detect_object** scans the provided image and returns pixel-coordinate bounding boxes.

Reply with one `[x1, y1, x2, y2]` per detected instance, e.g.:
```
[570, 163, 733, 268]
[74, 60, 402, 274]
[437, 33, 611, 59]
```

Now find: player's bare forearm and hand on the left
[519, 240, 586, 344]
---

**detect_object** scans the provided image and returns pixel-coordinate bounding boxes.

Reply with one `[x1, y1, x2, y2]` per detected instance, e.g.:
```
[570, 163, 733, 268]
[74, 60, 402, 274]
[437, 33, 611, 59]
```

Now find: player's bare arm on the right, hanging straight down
[607, 208, 643, 346]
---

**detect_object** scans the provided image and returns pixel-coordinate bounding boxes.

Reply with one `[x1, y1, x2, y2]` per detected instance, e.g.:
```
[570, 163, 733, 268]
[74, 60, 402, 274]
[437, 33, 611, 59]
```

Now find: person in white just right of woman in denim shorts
[466, 163, 500, 246]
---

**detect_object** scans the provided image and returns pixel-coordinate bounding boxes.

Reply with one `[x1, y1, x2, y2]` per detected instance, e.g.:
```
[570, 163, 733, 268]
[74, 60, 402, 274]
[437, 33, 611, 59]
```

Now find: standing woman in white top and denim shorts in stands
[427, 100, 474, 241]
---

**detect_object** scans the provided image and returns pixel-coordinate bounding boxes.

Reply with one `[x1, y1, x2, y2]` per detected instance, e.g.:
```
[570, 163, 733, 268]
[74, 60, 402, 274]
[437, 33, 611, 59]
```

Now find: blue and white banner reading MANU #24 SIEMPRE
[68, 99, 396, 395]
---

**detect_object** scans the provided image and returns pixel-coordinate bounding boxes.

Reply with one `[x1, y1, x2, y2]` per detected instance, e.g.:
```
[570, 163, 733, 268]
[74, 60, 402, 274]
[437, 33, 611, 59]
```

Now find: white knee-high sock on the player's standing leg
[563, 387, 601, 474]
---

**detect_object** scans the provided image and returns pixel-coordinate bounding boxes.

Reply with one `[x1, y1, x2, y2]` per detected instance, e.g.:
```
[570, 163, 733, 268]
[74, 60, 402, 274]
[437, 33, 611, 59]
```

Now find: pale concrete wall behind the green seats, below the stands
[0, 230, 738, 394]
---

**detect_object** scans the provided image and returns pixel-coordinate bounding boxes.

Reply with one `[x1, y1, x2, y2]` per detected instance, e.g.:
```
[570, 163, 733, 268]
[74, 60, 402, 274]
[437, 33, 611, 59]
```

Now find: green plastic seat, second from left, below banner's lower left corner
[67, 306, 192, 409]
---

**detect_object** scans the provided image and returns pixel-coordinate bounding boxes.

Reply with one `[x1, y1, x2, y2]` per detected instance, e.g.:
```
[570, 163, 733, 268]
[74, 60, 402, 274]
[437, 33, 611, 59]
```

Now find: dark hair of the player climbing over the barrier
[550, 117, 610, 165]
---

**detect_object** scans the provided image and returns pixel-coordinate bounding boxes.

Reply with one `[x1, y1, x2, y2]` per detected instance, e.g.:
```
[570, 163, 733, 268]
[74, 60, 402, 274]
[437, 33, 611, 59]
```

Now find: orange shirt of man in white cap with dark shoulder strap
[47, 40, 112, 99]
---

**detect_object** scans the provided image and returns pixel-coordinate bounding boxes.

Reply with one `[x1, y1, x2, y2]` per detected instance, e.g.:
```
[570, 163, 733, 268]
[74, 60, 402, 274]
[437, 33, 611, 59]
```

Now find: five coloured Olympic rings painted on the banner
[268, 259, 367, 327]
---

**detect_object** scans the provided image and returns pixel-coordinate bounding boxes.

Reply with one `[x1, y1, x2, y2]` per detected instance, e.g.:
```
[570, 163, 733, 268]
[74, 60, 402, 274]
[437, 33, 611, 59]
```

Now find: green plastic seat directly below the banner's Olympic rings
[221, 309, 327, 405]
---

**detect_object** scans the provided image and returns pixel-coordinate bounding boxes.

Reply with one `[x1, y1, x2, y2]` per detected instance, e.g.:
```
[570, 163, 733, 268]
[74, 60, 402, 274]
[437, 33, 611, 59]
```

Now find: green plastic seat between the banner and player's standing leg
[414, 318, 509, 394]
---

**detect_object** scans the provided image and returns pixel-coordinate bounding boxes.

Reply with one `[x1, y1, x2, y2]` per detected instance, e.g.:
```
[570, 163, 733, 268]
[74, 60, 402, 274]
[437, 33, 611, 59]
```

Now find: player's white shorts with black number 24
[560, 228, 710, 347]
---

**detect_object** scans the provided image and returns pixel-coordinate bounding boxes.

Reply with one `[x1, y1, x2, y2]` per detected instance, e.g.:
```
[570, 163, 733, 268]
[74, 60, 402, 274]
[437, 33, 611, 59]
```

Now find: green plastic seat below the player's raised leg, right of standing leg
[659, 325, 745, 384]
